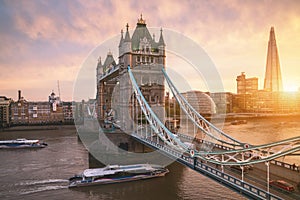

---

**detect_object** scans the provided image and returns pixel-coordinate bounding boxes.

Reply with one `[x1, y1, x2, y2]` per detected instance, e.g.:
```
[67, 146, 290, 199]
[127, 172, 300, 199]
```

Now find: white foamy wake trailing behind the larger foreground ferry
[16, 179, 69, 195]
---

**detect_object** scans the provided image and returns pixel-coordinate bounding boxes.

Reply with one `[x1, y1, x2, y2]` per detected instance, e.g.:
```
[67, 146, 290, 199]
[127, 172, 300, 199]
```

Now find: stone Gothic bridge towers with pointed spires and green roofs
[97, 16, 166, 130]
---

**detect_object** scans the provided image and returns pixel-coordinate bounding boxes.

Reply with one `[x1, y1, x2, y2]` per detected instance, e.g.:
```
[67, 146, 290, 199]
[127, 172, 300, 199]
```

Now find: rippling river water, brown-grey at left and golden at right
[0, 115, 300, 200]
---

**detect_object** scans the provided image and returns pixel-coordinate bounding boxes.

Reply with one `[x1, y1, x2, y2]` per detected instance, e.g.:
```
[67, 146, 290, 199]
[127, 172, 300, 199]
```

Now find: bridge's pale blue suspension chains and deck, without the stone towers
[128, 66, 300, 199]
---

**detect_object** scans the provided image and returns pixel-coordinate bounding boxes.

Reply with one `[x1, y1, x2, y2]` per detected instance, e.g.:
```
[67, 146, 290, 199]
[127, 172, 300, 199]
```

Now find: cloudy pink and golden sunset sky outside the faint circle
[0, 0, 300, 101]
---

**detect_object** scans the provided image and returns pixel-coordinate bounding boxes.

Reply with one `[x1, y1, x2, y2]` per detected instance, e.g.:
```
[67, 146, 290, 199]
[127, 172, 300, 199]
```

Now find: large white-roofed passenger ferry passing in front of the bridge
[69, 164, 169, 188]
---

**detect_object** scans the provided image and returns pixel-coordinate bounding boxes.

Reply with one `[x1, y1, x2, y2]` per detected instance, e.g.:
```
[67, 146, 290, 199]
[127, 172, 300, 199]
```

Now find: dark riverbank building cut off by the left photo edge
[0, 96, 12, 127]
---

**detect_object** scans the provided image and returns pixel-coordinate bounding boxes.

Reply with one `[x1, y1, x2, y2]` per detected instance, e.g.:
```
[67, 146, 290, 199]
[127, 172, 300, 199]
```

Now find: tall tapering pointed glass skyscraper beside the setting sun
[264, 27, 282, 92]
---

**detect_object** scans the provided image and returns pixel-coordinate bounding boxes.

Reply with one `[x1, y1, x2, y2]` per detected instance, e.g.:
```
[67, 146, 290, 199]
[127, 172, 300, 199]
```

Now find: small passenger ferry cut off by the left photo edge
[0, 138, 48, 148]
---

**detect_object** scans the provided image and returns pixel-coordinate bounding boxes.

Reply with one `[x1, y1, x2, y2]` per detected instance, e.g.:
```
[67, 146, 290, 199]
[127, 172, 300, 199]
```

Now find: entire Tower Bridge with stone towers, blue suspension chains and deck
[97, 16, 300, 199]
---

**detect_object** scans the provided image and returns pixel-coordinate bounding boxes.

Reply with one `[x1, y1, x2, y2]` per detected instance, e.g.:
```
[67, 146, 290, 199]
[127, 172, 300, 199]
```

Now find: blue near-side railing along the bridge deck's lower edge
[133, 135, 281, 200]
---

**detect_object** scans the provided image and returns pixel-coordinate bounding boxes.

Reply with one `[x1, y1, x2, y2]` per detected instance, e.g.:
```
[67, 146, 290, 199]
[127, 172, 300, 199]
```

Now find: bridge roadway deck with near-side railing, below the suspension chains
[132, 134, 300, 200]
